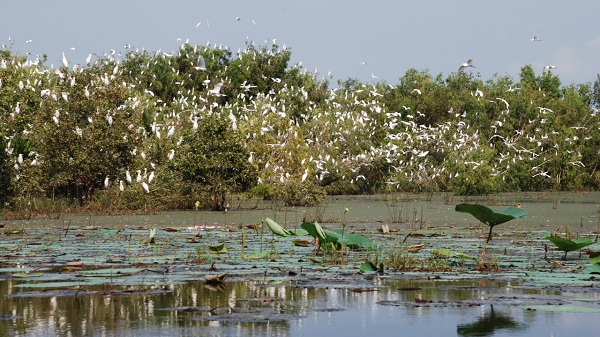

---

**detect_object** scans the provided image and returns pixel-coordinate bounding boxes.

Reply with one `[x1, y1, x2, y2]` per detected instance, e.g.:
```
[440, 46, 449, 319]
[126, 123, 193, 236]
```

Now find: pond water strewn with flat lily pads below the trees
[0, 193, 600, 336]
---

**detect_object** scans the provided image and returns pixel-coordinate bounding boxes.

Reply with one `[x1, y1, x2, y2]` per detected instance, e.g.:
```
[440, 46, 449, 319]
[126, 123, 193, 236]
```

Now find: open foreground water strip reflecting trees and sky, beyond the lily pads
[0, 279, 598, 336]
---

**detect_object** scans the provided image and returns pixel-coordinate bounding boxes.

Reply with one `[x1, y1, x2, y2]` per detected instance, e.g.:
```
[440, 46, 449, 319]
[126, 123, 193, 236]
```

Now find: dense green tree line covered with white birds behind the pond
[0, 43, 600, 213]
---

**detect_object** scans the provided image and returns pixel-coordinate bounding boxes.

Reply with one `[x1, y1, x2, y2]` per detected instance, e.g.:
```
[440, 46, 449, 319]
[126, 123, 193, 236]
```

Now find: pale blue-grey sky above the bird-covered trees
[0, 0, 600, 86]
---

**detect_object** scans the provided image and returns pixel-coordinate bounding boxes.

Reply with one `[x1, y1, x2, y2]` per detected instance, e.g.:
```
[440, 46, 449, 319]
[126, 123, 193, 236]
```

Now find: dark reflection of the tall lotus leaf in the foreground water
[456, 306, 525, 336]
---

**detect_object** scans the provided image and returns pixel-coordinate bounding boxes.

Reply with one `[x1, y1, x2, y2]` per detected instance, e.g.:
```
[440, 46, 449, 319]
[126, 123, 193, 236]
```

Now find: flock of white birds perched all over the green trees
[0, 29, 597, 200]
